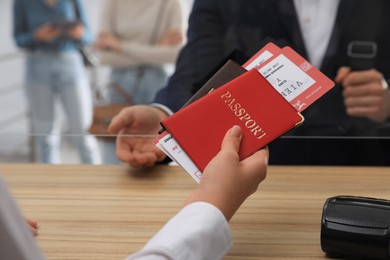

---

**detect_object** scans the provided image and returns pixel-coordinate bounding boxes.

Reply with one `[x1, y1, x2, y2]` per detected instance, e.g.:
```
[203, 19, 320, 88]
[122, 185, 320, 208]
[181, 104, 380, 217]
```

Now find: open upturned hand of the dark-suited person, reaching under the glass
[108, 105, 168, 167]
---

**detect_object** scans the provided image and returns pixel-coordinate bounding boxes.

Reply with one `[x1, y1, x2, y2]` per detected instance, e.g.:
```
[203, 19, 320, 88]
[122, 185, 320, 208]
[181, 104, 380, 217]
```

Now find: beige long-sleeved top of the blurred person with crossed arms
[99, 0, 184, 67]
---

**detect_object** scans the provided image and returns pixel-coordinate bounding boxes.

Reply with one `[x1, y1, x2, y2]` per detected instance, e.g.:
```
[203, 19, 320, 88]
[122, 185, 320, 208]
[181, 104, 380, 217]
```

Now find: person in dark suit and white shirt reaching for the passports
[109, 0, 390, 166]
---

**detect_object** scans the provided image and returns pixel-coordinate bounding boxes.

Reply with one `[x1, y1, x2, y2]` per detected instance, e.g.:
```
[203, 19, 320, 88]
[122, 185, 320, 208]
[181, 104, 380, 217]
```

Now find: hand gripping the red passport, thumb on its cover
[185, 126, 269, 221]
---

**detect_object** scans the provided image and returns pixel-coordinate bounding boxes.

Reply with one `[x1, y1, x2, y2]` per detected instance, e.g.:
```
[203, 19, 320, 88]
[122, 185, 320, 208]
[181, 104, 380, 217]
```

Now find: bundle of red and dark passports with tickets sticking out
[155, 43, 334, 182]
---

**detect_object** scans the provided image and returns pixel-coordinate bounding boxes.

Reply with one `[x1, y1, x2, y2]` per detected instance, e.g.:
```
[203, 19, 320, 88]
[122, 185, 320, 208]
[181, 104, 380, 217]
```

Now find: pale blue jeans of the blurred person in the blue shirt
[26, 51, 101, 164]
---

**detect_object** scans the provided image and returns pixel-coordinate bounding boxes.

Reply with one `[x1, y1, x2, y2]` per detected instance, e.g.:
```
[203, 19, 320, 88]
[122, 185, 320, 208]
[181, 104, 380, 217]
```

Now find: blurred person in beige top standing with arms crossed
[94, 0, 184, 163]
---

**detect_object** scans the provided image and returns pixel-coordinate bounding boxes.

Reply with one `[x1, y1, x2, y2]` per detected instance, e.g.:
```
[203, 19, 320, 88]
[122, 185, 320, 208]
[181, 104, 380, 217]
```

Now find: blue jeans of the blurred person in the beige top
[102, 65, 168, 164]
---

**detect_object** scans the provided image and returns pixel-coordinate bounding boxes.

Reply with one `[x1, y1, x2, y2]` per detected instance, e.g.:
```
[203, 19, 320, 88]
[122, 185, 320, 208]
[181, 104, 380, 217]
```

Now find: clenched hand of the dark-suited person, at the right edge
[335, 67, 390, 123]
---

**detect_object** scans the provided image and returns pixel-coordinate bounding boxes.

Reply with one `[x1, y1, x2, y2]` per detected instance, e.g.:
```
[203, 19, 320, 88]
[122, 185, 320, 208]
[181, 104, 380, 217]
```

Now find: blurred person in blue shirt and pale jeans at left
[13, 0, 101, 164]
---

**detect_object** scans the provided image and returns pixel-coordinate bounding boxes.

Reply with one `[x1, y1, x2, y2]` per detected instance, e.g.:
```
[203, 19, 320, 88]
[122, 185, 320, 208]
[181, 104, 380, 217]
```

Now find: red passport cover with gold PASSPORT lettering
[161, 69, 303, 172]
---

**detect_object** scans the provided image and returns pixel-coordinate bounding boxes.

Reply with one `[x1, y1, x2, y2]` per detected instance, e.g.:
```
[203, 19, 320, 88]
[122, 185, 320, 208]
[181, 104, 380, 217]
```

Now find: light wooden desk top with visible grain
[0, 164, 390, 260]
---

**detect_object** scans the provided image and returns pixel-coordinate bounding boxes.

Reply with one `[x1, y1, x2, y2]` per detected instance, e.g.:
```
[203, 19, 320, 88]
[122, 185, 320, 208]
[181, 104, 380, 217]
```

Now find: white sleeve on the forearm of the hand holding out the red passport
[127, 202, 232, 260]
